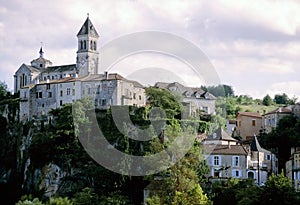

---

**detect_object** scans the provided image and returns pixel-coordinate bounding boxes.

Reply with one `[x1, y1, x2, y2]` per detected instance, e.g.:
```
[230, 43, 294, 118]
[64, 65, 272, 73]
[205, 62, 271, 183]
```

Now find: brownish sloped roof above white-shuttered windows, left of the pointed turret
[204, 144, 248, 155]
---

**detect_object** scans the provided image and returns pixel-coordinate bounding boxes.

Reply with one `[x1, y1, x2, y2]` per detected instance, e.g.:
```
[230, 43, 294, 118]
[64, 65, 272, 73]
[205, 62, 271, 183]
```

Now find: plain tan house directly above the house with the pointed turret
[235, 112, 262, 141]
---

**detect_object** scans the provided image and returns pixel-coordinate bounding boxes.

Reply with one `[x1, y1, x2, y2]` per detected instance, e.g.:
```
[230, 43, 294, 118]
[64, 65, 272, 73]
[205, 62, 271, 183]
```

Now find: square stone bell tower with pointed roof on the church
[76, 16, 99, 77]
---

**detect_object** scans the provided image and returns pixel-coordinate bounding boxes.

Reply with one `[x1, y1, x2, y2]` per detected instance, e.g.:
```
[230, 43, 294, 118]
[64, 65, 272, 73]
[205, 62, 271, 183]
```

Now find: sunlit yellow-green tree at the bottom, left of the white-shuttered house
[147, 143, 211, 205]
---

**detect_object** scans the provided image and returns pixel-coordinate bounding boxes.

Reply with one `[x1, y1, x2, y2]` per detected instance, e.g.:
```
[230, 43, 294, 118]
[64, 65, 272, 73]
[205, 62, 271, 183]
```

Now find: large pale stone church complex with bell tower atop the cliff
[14, 17, 146, 120]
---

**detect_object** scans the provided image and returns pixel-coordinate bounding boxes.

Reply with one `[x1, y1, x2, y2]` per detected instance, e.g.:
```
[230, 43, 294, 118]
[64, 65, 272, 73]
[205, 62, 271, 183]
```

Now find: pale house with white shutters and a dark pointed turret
[203, 129, 278, 185]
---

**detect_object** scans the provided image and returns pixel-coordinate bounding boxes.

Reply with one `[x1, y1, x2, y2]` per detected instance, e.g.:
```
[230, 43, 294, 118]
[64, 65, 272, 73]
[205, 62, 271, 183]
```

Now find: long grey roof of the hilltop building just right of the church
[154, 82, 216, 99]
